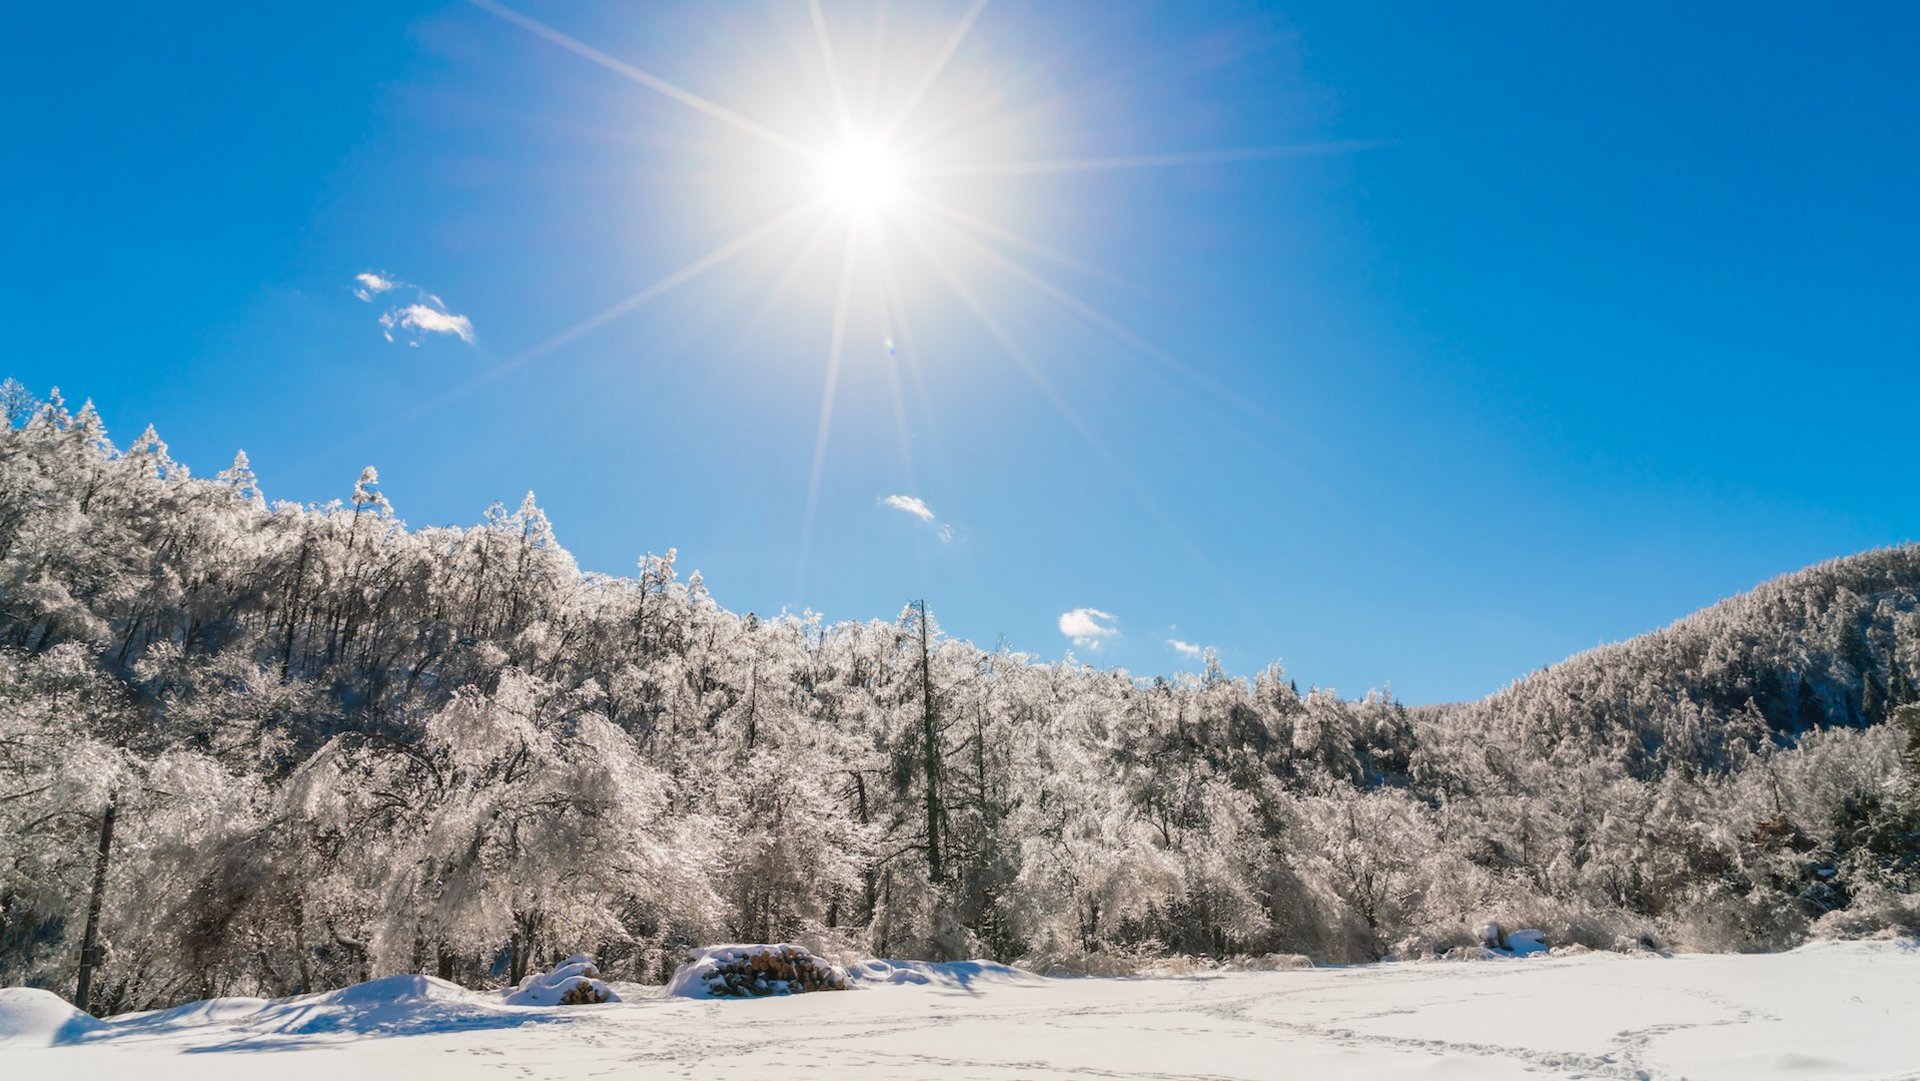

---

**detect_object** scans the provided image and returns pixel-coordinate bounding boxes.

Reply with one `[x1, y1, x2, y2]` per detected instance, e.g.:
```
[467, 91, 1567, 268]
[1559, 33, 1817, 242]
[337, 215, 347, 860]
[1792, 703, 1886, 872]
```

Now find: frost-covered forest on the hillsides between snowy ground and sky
[0, 382, 1920, 1012]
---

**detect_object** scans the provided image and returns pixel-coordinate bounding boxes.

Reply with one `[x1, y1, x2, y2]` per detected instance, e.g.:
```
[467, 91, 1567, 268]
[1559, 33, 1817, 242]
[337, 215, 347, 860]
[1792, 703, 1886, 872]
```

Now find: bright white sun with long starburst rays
[460, 0, 1320, 595]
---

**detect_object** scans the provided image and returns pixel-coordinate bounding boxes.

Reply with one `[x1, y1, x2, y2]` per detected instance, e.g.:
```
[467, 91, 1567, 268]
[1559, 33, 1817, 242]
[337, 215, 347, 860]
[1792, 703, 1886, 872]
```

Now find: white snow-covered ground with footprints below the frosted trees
[0, 943, 1920, 1081]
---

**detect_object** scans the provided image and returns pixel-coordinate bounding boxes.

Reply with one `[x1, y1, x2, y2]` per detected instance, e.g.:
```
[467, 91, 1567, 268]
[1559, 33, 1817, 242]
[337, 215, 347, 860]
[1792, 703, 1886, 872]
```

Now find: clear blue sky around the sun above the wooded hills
[0, 2, 1920, 701]
